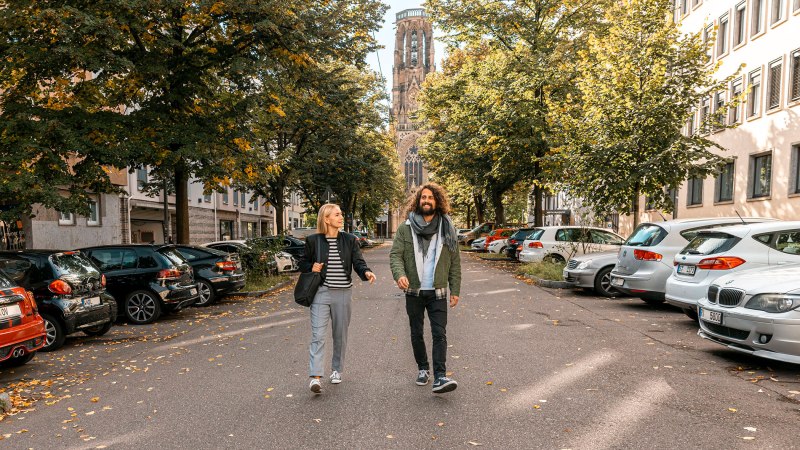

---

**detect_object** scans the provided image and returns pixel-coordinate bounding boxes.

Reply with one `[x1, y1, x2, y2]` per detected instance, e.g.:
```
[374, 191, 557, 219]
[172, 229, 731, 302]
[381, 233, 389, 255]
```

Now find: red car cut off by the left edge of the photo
[0, 271, 46, 367]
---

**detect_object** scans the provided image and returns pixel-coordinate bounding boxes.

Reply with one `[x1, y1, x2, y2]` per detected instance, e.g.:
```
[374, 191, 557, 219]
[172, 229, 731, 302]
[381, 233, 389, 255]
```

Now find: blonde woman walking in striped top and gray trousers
[300, 203, 375, 394]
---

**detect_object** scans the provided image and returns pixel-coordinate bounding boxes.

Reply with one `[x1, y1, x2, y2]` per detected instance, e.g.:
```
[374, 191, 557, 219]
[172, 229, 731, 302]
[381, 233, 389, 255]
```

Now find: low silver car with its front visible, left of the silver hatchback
[564, 250, 622, 297]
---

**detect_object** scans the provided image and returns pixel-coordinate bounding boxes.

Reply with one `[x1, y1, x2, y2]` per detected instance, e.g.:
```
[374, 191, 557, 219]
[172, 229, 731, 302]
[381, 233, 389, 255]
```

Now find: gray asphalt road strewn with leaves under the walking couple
[0, 246, 800, 449]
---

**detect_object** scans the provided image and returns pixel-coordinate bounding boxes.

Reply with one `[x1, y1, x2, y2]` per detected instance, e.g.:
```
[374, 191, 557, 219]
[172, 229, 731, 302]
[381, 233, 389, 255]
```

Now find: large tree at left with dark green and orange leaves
[0, 0, 385, 239]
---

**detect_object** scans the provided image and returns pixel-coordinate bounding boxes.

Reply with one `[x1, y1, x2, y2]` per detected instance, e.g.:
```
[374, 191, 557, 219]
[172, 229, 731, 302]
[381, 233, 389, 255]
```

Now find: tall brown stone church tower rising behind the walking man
[389, 8, 436, 235]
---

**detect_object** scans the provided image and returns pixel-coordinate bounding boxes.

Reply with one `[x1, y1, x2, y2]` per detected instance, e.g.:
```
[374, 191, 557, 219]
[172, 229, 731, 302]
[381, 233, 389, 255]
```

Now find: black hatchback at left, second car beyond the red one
[81, 244, 200, 324]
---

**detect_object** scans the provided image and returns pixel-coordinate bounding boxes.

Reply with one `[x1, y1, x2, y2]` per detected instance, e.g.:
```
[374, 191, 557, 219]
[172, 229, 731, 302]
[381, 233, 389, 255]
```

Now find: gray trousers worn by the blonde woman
[308, 286, 353, 377]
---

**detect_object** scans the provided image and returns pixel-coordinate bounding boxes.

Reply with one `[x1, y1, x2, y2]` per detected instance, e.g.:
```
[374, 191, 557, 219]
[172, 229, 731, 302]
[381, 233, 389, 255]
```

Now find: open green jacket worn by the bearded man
[389, 222, 461, 296]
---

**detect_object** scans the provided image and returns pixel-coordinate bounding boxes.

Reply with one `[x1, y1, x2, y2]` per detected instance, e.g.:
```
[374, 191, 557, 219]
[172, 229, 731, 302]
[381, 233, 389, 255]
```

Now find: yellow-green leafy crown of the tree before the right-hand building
[551, 0, 740, 226]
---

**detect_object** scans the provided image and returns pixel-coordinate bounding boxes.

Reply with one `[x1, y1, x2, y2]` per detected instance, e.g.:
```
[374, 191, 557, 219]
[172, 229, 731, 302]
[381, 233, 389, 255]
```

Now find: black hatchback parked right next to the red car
[0, 250, 117, 352]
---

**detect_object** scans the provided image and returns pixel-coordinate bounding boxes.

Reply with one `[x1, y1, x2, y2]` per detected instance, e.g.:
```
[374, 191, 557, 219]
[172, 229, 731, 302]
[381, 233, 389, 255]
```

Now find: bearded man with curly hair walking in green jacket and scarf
[389, 183, 461, 394]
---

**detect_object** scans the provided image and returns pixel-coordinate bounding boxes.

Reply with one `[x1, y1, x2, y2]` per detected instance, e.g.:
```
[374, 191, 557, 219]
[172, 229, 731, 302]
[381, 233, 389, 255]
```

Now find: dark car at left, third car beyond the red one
[175, 245, 245, 306]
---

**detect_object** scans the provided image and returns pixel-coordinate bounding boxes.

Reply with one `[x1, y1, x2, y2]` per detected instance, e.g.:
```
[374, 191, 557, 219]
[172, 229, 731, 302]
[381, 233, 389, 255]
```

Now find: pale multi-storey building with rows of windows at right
[643, 0, 800, 232]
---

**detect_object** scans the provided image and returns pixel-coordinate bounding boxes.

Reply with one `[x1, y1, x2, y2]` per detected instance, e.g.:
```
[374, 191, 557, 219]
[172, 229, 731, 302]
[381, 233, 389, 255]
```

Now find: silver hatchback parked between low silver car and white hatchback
[611, 217, 772, 304]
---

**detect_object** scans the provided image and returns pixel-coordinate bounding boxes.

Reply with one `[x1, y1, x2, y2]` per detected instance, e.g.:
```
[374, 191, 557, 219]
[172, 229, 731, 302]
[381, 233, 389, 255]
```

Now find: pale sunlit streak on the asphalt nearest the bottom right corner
[572, 379, 674, 449]
